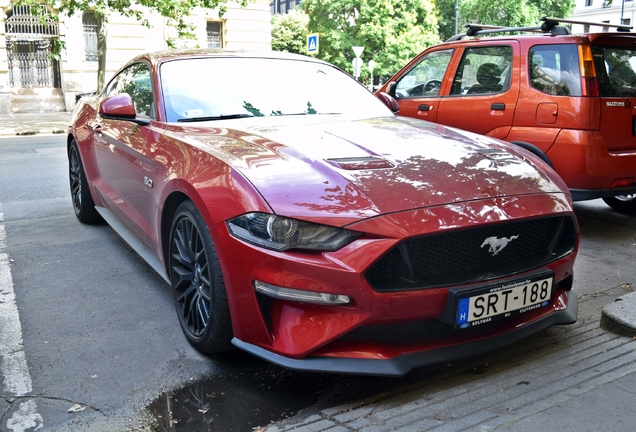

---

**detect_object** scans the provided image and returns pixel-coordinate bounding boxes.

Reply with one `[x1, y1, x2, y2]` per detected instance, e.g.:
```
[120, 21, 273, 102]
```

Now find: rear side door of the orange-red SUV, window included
[437, 40, 519, 139]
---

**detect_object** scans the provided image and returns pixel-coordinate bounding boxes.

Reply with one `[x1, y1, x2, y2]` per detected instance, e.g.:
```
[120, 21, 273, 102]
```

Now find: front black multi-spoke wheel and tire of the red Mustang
[169, 201, 232, 354]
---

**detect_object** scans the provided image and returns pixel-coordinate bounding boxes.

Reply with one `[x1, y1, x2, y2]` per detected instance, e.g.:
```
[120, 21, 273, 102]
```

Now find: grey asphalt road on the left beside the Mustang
[0, 135, 223, 431]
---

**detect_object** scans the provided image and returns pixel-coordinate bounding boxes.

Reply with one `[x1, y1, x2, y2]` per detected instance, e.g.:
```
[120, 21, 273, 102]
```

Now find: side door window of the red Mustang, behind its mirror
[106, 63, 156, 118]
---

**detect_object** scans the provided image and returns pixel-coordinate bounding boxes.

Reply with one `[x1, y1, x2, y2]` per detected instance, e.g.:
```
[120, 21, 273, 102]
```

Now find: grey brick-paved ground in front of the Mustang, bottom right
[266, 290, 636, 432]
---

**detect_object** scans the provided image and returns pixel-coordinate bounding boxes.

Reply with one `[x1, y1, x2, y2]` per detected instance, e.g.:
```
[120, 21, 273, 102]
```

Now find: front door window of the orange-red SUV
[395, 50, 454, 98]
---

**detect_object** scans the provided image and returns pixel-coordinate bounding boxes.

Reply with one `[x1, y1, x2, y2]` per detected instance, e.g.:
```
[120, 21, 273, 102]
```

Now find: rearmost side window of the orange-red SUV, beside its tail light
[528, 44, 581, 96]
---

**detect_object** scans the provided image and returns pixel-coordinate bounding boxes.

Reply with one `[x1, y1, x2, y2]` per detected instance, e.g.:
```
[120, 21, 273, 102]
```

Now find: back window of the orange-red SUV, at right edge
[592, 45, 636, 97]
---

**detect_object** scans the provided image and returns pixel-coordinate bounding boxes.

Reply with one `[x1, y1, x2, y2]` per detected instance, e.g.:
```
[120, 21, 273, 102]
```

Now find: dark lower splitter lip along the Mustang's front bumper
[232, 291, 579, 377]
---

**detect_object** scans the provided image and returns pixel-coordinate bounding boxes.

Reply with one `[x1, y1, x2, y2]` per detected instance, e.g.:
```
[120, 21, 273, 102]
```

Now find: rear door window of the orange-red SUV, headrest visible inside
[451, 45, 512, 95]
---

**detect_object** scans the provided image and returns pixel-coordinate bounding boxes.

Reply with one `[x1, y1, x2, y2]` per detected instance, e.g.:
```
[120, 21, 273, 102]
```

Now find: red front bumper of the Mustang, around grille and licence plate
[214, 194, 578, 376]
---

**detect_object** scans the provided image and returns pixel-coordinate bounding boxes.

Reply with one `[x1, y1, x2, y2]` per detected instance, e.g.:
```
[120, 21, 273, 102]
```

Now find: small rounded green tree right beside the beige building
[272, 8, 309, 54]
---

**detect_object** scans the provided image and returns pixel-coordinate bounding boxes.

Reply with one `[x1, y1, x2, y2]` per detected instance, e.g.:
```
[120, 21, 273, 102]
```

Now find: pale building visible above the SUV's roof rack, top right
[572, 0, 636, 33]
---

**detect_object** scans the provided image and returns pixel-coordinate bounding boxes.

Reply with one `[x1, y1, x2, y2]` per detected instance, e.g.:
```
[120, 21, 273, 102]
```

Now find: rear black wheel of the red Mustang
[68, 140, 101, 223]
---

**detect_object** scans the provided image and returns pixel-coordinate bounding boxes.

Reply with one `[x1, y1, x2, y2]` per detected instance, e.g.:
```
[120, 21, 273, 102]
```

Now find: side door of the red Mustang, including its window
[93, 62, 154, 244]
